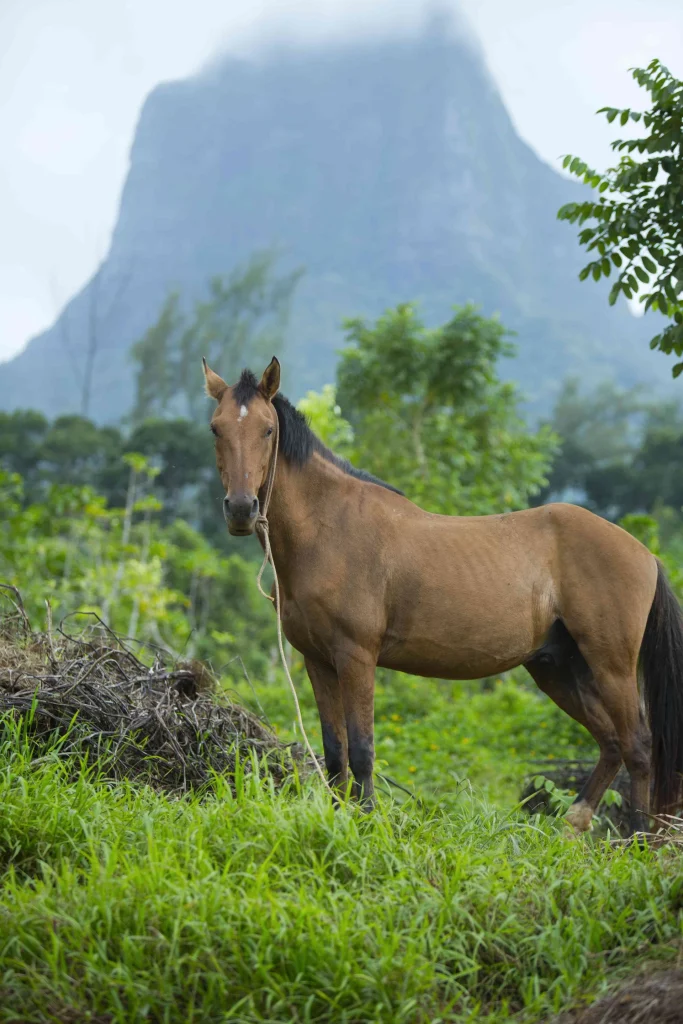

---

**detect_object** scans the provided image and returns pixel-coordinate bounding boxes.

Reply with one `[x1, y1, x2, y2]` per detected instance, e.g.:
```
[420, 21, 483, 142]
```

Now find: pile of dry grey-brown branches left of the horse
[0, 585, 310, 794]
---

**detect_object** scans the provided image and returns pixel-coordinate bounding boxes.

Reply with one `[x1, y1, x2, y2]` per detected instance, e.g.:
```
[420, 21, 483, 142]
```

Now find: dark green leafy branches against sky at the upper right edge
[558, 60, 683, 377]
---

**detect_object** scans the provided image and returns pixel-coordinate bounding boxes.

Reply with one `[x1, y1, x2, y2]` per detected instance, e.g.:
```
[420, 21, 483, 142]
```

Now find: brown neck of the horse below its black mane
[260, 455, 340, 582]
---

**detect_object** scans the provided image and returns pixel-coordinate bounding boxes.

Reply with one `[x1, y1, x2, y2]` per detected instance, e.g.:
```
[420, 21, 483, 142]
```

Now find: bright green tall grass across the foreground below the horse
[0, 727, 683, 1024]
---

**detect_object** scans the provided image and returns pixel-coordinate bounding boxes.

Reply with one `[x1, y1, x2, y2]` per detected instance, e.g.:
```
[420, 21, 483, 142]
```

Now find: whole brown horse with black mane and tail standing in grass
[205, 358, 683, 830]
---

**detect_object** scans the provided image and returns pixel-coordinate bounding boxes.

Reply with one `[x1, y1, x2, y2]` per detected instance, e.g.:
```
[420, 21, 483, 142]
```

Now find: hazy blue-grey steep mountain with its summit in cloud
[0, 19, 668, 422]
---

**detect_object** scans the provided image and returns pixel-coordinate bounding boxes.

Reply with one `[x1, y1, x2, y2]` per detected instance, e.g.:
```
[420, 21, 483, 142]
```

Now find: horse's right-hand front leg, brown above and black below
[337, 650, 376, 811]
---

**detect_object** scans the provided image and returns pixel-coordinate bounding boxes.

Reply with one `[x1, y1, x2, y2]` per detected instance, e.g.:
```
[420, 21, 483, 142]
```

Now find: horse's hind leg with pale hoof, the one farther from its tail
[524, 623, 622, 831]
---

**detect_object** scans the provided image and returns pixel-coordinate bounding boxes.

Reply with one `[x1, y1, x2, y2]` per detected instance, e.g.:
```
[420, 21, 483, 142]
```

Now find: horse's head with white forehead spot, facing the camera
[204, 355, 280, 537]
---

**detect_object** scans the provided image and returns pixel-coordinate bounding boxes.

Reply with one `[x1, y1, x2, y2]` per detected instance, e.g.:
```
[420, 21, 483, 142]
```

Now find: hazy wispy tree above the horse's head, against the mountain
[131, 252, 301, 423]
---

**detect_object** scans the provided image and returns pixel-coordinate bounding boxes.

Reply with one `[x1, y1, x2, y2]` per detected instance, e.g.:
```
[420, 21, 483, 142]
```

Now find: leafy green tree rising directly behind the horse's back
[337, 305, 554, 515]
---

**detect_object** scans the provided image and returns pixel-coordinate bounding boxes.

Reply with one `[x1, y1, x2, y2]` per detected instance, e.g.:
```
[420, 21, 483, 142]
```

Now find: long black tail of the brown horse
[640, 562, 683, 814]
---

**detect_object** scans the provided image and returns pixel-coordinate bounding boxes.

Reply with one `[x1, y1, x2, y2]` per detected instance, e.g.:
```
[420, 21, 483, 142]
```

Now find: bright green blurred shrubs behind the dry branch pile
[0, 468, 274, 676]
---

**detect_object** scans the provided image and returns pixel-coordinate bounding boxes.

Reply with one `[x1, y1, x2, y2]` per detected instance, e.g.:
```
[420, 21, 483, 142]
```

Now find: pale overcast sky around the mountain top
[0, 0, 683, 358]
